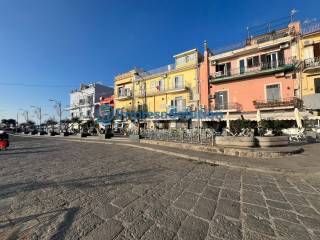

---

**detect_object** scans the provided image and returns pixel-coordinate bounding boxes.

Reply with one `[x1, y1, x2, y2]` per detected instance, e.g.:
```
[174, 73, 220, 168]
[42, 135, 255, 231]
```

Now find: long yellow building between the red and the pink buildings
[114, 49, 201, 127]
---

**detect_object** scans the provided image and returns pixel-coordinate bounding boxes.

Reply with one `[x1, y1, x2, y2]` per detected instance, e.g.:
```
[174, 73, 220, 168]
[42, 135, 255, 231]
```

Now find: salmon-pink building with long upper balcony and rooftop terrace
[200, 23, 301, 117]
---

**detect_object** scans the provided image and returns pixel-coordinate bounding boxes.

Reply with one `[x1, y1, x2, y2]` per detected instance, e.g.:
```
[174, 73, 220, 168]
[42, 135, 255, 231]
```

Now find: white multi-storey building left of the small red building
[69, 83, 113, 120]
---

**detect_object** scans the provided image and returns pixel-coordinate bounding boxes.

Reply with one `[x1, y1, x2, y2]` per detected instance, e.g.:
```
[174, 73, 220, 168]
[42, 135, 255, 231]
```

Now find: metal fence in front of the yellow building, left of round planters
[140, 128, 218, 145]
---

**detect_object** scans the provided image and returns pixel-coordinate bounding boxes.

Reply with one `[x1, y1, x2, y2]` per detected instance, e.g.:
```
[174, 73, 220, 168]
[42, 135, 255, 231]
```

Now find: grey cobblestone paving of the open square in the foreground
[0, 138, 320, 240]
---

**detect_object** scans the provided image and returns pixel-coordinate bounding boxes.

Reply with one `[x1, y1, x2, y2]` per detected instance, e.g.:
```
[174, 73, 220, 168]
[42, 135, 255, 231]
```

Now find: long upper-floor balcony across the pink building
[210, 58, 297, 83]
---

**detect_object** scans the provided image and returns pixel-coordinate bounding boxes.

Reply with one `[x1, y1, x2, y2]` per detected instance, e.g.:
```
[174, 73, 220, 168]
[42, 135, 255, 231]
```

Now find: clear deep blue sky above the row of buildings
[0, 0, 320, 119]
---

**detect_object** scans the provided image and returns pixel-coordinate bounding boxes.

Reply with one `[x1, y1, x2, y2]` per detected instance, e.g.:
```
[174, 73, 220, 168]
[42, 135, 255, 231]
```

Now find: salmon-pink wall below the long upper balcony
[210, 75, 294, 112]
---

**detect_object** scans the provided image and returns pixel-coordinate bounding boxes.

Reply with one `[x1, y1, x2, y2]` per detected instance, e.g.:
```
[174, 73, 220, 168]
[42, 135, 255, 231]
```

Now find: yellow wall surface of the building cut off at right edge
[299, 32, 320, 96]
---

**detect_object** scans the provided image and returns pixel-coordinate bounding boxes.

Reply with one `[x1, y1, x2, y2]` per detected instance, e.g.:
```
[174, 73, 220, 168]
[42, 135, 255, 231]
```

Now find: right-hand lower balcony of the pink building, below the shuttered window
[253, 97, 303, 110]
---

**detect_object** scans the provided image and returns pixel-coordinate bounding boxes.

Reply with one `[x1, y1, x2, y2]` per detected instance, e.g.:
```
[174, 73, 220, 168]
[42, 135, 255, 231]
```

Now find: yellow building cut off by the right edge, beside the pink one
[299, 22, 320, 111]
